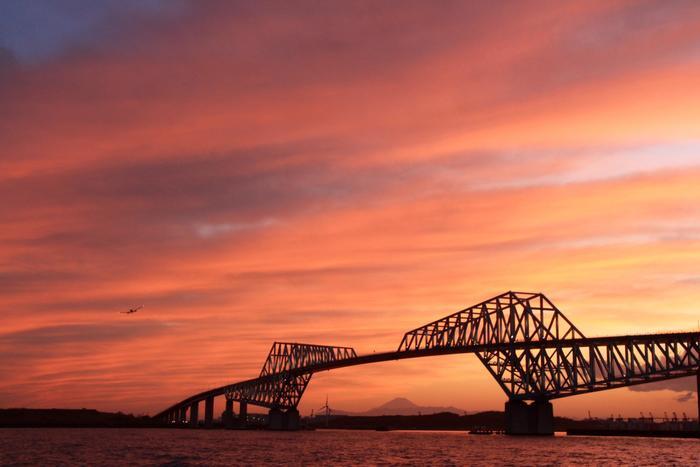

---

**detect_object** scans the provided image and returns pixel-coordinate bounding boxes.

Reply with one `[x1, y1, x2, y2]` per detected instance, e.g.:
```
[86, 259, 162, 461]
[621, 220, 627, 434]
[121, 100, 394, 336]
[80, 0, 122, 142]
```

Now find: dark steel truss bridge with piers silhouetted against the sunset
[156, 291, 700, 434]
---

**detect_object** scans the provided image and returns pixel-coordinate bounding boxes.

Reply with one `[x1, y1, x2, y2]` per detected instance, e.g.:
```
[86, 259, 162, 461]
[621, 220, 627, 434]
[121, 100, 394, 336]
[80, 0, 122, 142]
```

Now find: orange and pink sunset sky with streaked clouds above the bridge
[0, 0, 700, 417]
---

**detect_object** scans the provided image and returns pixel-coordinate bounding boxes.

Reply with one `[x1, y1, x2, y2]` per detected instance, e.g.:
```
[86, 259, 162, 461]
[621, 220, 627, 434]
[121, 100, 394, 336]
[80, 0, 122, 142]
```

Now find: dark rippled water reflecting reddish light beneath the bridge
[0, 428, 700, 466]
